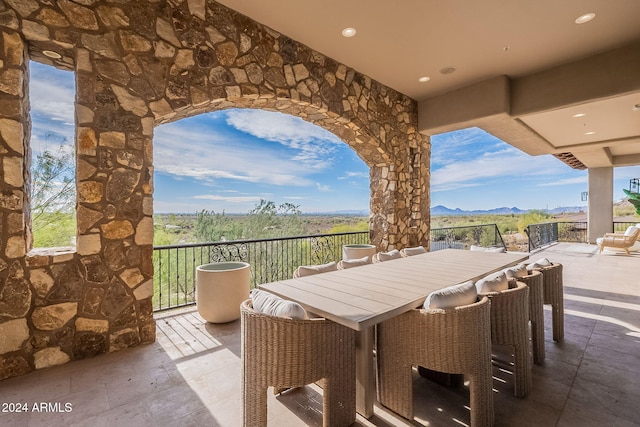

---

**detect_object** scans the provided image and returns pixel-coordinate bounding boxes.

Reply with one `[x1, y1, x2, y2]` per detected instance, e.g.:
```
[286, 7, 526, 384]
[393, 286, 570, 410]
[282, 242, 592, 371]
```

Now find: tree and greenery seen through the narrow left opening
[30, 134, 76, 247]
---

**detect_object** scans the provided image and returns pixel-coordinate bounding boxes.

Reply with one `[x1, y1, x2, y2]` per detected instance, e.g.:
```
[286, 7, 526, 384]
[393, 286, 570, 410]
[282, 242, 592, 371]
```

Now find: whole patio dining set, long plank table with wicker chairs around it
[209, 248, 564, 426]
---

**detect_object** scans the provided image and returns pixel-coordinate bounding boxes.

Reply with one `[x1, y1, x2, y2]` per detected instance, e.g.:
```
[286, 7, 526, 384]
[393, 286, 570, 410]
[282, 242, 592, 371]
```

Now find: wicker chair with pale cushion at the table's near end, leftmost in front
[240, 300, 356, 427]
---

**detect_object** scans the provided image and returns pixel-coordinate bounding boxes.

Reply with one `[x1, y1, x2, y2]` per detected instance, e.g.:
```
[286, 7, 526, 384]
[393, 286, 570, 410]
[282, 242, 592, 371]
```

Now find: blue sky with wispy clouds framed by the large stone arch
[154, 109, 369, 221]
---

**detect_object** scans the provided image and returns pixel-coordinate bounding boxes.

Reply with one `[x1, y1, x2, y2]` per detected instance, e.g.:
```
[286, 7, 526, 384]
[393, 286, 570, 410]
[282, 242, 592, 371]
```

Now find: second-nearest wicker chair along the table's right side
[478, 282, 531, 397]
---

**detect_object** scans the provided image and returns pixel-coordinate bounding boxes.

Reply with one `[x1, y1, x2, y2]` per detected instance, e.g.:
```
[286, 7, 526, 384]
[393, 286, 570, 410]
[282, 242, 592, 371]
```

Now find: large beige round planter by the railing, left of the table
[196, 261, 250, 323]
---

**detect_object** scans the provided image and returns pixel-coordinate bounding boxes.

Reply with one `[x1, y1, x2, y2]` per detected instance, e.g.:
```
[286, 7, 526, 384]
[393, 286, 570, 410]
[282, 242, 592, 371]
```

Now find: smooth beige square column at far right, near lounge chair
[587, 167, 613, 243]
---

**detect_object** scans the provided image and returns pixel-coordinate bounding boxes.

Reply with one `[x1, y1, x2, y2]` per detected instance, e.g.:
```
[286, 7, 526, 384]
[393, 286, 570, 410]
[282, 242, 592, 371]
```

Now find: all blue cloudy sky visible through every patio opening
[30, 62, 640, 213]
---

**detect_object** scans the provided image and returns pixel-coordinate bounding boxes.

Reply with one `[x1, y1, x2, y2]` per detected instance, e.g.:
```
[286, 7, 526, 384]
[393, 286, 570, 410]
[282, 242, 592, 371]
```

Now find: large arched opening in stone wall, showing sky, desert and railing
[153, 108, 370, 310]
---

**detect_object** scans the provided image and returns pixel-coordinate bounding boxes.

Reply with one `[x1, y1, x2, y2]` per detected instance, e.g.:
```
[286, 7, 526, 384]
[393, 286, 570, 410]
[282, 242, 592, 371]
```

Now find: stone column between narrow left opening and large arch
[76, 49, 155, 357]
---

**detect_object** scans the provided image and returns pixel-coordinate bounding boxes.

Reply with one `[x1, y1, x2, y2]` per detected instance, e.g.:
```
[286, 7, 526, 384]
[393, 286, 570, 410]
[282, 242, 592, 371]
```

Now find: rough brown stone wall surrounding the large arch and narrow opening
[0, 0, 430, 379]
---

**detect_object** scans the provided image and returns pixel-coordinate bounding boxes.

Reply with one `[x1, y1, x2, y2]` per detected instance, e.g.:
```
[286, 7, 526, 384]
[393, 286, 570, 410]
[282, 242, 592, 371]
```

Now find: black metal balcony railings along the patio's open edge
[153, 222, 635, 310]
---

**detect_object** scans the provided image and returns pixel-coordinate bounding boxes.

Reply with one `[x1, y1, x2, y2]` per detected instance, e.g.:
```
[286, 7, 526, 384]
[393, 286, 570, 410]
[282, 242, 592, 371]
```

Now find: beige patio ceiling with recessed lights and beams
[219, 0, 640, 168]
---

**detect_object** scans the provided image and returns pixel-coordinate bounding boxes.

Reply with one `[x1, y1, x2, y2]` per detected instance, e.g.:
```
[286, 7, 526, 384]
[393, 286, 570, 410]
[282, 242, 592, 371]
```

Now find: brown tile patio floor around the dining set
[0, 243, 640, 427]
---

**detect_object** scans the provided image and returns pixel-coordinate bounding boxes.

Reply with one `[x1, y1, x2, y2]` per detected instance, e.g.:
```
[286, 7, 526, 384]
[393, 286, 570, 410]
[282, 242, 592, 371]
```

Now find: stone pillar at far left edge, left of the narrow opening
[0, 29, 32, 379]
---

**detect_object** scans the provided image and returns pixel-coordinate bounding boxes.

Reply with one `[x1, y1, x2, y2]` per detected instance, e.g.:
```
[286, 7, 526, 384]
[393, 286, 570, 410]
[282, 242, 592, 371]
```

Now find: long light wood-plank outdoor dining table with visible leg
[260, 249, 529, 418]
